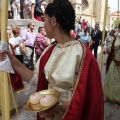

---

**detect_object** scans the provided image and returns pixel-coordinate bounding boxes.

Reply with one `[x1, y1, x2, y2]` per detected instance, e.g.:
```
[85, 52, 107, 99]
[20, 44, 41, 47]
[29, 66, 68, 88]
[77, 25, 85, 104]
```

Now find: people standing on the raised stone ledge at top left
[8, 0, 48, 21]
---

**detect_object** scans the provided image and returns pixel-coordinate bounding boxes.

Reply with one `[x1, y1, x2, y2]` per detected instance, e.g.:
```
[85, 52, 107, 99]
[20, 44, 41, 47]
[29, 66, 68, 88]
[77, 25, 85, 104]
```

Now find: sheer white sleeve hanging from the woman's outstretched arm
[25, 73, 38, 95]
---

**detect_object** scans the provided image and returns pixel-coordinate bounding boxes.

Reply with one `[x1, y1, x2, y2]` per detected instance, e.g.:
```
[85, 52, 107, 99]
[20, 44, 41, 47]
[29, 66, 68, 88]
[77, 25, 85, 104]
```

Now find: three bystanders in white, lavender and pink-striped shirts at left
[7, 22, 50, 70]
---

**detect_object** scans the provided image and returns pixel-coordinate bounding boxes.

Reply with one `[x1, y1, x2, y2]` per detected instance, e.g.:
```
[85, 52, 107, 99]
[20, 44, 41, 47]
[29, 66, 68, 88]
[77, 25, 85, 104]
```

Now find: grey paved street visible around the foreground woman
[0, 48, 120, 120]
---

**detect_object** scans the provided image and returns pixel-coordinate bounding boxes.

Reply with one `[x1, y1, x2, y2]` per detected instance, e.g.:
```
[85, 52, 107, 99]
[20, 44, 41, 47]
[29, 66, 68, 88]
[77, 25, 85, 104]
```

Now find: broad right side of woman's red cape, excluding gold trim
[63, 48, 104, 120]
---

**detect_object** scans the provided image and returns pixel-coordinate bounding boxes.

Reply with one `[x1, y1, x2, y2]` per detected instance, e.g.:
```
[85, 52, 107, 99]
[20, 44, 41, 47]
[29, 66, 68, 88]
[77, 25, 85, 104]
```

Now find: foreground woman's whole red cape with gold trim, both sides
[37, 45, 104, 120]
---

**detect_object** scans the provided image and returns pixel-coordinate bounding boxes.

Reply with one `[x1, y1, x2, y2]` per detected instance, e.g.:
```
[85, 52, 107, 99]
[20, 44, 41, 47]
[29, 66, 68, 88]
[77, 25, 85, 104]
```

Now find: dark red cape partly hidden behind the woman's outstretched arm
[8, 43, 24, 91]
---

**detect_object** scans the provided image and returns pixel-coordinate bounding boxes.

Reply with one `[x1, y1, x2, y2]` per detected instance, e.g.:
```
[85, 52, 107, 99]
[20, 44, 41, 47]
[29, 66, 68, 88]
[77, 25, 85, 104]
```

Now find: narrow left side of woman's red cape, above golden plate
[37, 45, 55, 120]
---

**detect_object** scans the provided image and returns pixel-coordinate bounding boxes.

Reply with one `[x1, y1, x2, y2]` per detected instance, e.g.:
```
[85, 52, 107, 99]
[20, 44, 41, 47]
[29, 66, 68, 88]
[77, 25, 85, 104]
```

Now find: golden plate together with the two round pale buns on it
[24, 89, 60, 112]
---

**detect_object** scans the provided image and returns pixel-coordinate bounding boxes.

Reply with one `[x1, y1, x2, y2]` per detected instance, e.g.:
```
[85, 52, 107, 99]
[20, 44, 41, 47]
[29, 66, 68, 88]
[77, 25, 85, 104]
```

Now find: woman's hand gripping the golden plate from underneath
[39, 103, 60, 118]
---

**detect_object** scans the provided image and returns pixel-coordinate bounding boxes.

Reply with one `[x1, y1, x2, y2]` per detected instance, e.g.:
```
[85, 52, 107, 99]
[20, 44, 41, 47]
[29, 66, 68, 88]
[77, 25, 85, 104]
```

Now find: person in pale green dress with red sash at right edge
[104, 24, 120, 108]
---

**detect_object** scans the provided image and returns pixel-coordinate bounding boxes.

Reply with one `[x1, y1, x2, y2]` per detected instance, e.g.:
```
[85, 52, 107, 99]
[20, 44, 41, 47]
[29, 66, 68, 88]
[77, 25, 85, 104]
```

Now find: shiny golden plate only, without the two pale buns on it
[24, 89, 60, 112]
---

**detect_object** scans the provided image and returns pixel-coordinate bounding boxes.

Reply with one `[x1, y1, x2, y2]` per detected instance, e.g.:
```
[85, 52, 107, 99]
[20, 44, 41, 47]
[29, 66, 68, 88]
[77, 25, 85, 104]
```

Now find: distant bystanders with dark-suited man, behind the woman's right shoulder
[71, 19, 102, 59]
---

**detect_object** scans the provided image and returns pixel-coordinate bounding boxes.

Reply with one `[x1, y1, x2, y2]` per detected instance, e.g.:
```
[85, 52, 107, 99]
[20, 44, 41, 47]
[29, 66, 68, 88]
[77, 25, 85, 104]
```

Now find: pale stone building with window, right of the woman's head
[70, 0, 110, 30]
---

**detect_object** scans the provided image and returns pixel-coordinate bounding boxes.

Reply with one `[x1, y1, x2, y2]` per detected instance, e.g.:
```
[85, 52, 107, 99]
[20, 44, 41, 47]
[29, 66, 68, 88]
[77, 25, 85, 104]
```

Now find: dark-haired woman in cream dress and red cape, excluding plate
[0, 0, 104, 120]
